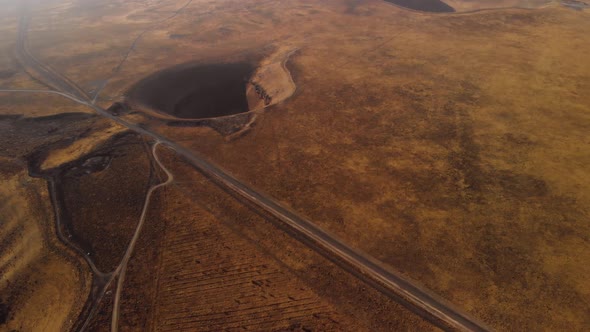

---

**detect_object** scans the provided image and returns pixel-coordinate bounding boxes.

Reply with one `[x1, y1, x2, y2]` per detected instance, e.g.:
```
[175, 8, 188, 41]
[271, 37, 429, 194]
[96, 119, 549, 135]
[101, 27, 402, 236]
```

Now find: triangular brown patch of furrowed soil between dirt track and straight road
[150, 188, 352, 331]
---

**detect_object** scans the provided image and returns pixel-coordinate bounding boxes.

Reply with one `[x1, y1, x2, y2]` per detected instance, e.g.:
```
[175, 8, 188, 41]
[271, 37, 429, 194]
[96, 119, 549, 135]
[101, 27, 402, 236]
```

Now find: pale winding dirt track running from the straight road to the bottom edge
[111, 142, 174, 332]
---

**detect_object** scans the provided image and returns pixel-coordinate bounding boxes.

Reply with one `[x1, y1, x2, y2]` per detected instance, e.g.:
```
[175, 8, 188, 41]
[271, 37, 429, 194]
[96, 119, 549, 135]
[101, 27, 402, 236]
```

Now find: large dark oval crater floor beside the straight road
[127, 62, 255, 119]
